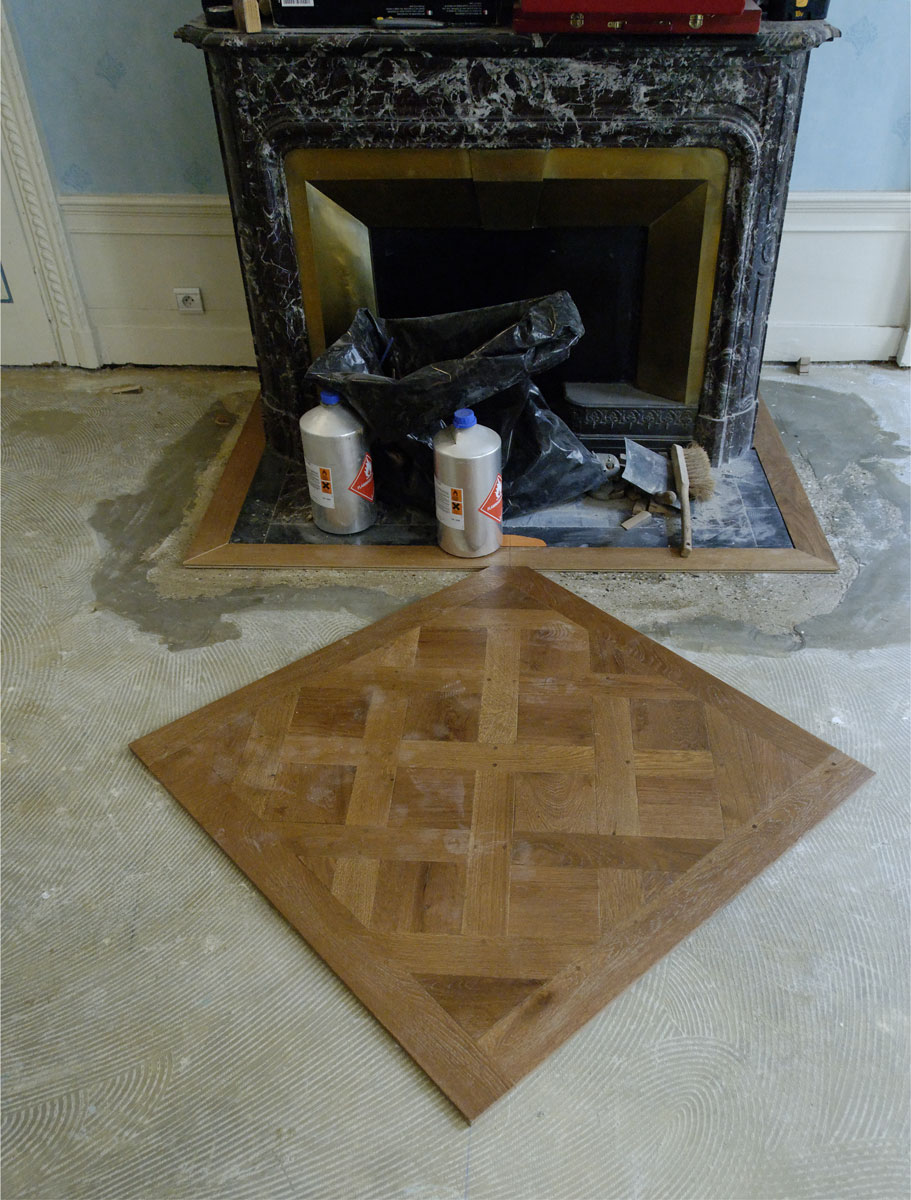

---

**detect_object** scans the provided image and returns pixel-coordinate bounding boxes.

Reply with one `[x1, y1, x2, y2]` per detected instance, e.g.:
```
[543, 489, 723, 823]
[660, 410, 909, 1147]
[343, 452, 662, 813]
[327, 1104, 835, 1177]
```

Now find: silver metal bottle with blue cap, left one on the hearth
[300, 391, 377, 533]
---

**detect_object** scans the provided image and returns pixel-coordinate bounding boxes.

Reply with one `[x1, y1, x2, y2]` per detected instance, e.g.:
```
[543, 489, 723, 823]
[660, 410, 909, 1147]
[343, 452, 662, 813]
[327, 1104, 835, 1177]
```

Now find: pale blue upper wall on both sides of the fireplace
[5, 0, 911, 194]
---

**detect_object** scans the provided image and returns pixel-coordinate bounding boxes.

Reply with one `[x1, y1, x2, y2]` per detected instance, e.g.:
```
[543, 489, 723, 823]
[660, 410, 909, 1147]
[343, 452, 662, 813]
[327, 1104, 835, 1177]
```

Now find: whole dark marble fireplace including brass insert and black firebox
[176, 20, 838, 464]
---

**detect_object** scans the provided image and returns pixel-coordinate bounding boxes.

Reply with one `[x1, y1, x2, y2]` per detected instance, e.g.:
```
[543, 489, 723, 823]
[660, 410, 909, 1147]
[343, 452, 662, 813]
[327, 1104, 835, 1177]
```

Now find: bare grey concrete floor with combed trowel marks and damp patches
[2, 366, 909, 1200]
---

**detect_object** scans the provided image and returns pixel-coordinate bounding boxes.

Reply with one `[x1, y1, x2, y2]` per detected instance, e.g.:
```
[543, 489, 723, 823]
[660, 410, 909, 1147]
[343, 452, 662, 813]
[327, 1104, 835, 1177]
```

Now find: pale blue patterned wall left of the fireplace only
[4, 0, 226, 194]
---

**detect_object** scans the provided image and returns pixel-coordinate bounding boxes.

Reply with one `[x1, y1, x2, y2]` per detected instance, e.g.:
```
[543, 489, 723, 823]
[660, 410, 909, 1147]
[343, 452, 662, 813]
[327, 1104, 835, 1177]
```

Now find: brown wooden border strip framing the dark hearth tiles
[184, 401, 838, 571]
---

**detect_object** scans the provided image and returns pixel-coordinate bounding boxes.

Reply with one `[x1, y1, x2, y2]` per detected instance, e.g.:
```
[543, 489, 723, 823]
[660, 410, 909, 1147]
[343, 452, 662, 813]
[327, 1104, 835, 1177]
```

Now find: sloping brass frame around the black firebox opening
[284, 146, 729, 406]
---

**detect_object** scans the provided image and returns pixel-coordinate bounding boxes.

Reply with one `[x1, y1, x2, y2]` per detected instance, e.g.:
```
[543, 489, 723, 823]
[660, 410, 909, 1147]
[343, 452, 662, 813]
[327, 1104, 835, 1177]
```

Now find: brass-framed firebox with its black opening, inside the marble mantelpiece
[286, 146, 727, 449]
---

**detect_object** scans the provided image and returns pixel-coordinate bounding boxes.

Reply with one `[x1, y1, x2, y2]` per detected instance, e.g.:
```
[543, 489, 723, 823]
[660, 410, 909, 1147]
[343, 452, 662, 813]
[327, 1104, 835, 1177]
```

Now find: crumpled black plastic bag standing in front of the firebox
[307, 292, 606, 517]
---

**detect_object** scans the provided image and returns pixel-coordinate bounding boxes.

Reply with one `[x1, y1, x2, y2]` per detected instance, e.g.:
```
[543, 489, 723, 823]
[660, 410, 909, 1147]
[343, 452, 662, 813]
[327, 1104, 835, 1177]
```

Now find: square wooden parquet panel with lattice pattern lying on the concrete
[132, 568, 870, 1120]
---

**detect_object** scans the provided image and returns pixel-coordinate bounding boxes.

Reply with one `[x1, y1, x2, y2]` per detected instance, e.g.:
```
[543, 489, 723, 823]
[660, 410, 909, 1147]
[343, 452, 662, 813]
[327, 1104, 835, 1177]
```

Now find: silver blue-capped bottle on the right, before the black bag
[433, 408, 503, 558]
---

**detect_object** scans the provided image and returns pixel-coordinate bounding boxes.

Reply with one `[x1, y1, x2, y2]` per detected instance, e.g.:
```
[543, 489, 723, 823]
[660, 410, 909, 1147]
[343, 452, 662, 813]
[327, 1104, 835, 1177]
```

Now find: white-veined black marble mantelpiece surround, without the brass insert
[176, 20, 838, 463]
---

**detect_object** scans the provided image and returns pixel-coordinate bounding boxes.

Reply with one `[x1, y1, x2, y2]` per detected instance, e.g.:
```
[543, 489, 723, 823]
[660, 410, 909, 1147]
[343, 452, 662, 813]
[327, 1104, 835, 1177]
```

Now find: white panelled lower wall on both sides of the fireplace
[60, 192, 911, 366]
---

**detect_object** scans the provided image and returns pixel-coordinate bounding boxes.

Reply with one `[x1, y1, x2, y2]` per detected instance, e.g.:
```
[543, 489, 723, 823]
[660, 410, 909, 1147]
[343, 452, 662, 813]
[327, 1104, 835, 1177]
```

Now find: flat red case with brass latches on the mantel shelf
[513, 0, 762, 36]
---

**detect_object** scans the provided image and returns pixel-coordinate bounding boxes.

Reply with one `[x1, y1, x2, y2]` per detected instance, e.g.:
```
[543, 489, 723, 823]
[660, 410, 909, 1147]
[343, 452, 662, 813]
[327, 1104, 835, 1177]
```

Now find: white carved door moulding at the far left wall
[0, 10, 101, 367]
